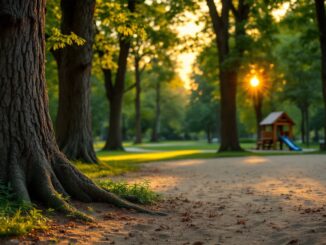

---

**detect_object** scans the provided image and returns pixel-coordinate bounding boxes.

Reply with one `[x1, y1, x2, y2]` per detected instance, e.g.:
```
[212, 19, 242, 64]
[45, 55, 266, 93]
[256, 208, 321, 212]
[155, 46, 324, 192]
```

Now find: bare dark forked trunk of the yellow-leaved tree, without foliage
[103, 0, 136, 151]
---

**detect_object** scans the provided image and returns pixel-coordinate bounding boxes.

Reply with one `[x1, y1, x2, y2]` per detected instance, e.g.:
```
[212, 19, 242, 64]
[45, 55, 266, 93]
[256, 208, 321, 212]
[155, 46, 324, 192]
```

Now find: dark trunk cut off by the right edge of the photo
[315, 0, 326, 146]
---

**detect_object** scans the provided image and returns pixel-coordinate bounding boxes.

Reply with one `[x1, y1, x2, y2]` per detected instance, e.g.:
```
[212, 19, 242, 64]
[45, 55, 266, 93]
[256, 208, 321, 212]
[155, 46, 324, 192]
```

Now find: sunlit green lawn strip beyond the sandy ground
[81, 141, 318, 179]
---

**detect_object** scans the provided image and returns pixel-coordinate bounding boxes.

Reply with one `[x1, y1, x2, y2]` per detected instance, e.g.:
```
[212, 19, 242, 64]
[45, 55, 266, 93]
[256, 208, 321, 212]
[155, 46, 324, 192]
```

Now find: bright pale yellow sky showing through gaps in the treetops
[177, 3, 289, 89]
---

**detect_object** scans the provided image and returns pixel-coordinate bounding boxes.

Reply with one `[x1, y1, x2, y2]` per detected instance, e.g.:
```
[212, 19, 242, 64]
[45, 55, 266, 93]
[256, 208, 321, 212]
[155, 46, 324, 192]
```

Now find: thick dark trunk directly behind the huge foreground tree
[55, 0, 97, 163]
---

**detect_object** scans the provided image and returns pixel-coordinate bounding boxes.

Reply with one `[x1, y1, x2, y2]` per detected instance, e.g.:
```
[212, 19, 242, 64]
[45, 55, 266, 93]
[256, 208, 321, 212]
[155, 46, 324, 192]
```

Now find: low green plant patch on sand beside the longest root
[98, 180, 161, 204]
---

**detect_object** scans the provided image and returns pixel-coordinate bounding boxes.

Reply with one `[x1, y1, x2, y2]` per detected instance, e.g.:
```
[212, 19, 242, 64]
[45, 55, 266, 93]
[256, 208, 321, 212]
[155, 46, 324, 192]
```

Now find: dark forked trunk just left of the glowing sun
[206, 0, 242, 152]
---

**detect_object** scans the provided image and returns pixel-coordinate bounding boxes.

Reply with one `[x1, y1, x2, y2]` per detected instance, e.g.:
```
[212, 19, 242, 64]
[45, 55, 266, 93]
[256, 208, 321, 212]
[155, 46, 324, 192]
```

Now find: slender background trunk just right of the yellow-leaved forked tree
[135, 57, 142, 144]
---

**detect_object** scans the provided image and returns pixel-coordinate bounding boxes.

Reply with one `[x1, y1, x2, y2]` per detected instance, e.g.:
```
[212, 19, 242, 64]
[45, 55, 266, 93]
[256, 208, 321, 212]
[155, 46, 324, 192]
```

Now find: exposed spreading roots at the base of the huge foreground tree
[11, 151, 166, 221]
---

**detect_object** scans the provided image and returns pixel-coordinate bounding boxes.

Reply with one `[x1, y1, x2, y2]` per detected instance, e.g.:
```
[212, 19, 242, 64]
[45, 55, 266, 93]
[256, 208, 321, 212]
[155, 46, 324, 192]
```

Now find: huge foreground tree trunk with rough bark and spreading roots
[0, 0, 161, 219]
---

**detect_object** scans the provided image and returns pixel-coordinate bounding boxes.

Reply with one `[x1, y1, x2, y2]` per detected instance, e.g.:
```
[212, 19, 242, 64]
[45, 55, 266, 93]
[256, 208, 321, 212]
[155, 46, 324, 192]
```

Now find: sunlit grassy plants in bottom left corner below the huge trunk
[0, 185, 48, 237]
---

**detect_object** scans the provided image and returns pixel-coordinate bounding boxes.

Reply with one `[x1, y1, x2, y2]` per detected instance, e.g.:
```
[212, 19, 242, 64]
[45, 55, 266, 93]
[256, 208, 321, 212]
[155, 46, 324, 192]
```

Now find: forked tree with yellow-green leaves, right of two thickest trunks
[97, 0, 140, 150]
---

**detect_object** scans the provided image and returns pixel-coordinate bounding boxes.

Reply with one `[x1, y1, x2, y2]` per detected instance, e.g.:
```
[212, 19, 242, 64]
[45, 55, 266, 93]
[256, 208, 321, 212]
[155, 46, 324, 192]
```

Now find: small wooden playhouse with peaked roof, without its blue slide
[257, 111, 295, 150]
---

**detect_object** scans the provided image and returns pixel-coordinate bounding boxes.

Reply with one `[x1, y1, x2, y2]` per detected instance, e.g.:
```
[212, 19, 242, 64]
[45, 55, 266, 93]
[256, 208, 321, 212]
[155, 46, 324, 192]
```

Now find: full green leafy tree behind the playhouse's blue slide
[274, 1, 321, 144]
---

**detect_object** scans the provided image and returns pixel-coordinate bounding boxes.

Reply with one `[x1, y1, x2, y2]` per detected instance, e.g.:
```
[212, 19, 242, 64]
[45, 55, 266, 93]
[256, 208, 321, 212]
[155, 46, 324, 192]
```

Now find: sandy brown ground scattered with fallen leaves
[3, 155, 326, 245]
